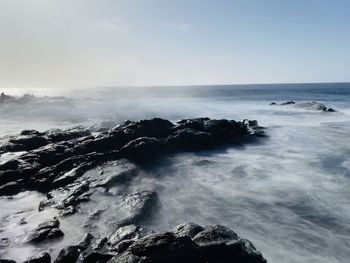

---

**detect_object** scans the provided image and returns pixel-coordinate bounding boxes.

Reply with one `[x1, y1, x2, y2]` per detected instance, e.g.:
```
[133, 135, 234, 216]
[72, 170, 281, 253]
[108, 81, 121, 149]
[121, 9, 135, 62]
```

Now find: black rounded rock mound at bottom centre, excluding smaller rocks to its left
[109, 223, 266, 263]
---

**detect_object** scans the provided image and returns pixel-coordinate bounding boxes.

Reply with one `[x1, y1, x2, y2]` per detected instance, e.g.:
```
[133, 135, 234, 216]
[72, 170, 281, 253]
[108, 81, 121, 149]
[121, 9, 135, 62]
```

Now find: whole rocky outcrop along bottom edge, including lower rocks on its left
[28, 223, 266, 263]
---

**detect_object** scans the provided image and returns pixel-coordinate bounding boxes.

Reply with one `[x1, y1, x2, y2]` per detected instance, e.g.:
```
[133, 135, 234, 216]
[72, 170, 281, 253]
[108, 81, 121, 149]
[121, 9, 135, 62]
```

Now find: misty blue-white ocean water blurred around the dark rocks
[0, 83, 350, 263]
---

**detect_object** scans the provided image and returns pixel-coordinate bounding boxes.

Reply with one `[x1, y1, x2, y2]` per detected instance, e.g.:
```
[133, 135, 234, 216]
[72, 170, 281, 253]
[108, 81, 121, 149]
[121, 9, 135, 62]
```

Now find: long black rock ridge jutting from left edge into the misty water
[0, 118, 265, 198]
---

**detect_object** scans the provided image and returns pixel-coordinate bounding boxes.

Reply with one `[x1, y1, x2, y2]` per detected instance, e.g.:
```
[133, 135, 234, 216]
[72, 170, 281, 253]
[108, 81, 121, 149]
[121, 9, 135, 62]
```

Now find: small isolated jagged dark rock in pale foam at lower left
[26, 218, 64, 243]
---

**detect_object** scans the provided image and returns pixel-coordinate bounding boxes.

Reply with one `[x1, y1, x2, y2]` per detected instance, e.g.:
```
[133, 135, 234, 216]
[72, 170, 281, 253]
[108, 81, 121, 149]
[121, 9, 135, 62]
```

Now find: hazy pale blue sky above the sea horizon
[0, 0, 350, 87]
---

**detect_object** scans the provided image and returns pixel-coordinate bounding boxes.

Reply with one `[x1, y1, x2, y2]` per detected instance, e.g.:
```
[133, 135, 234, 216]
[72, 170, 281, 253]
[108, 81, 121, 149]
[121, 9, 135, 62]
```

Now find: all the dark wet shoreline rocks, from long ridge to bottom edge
[0, 118, 266, 263]
